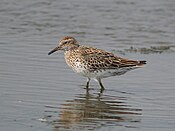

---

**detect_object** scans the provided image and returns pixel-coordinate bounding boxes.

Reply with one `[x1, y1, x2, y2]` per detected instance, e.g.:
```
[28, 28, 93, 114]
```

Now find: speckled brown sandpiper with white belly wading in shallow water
[48, 36, 146, 90]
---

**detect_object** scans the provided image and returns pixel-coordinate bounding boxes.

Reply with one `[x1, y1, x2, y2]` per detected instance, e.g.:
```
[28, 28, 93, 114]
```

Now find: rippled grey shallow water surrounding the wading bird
[0, 0, 175, 131]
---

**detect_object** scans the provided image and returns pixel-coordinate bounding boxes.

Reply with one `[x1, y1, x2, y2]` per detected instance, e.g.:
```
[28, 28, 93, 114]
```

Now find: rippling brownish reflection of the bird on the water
[44, 91, 142, 131]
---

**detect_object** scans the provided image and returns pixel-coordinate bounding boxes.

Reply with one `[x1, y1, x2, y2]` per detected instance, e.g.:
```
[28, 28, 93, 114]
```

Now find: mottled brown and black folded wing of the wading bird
[82, 47, 145, 69]
